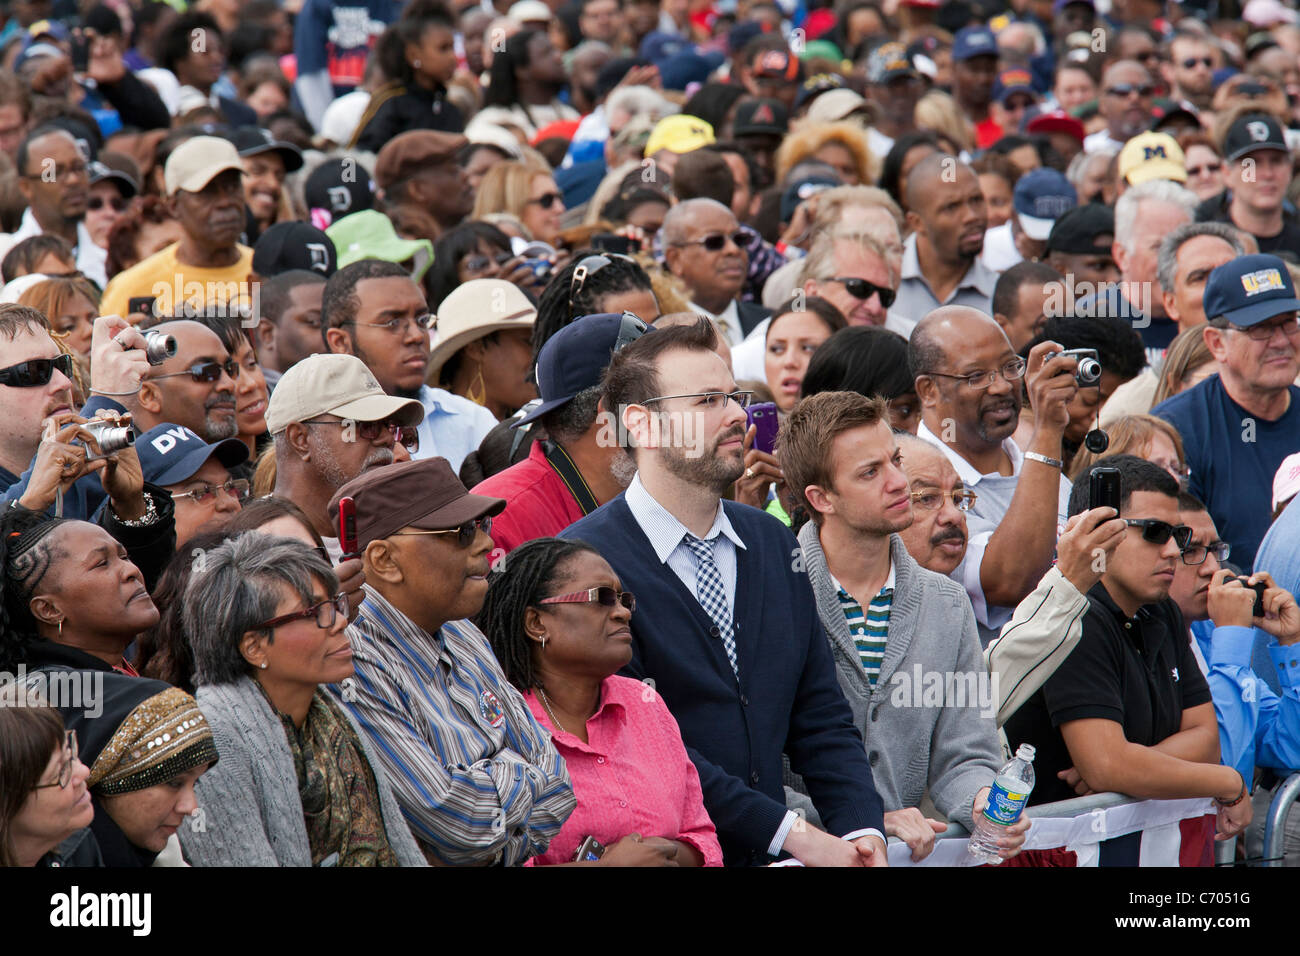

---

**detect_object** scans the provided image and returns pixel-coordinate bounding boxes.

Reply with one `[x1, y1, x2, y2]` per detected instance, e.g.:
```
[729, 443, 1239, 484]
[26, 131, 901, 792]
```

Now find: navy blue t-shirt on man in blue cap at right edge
[1151, 375, 1300, 570]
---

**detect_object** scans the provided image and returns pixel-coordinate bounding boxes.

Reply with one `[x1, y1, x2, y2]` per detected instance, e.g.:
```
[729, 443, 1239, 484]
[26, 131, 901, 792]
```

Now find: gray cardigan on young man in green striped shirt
[787, 522, 1002, 829]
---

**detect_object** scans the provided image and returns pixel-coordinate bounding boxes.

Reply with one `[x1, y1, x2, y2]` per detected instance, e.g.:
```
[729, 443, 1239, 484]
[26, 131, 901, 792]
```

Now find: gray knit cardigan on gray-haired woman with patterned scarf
[179, 678, 428, 866]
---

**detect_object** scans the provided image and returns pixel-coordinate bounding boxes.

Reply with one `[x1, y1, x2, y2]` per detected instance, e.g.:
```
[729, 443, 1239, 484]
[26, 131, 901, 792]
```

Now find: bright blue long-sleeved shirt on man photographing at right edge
[1192, 622, 1300, 780]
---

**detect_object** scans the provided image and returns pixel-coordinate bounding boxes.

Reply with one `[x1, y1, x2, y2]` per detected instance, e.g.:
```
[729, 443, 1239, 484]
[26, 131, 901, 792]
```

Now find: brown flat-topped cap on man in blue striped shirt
[329, 458, 506, 550]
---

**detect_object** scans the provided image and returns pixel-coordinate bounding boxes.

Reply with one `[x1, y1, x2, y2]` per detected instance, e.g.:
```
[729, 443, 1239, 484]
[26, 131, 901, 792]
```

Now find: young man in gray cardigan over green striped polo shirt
[780, 392, 1013, 860]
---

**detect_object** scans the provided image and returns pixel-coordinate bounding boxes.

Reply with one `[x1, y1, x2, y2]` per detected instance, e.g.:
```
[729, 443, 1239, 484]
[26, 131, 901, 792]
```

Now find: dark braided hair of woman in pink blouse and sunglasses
[475, 537, 597, 692]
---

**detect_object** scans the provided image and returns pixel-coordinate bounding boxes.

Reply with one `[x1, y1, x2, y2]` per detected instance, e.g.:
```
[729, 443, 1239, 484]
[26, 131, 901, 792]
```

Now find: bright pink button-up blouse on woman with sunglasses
[524, 676, 723, 866]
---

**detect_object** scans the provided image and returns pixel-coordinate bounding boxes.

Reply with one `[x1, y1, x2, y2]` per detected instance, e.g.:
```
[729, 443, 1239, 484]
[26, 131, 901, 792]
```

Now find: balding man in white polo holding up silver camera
[907, 306, 1076, 644]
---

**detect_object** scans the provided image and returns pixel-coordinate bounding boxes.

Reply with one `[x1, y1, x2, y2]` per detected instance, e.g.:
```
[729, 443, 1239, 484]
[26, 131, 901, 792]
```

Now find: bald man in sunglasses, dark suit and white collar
[660, 199, 771, 347]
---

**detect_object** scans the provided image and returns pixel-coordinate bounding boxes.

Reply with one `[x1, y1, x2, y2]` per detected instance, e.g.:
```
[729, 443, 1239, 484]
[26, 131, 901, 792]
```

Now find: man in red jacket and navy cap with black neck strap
[473, 312, 649, 555]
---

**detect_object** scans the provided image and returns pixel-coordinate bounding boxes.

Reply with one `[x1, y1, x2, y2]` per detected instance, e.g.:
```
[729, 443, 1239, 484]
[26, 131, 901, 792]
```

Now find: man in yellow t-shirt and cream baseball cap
[100, 137, 252, 316]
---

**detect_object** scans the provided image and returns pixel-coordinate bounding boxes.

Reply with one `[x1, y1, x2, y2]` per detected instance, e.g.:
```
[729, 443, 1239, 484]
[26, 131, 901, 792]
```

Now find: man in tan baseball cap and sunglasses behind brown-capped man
[267, 355, 424, 561]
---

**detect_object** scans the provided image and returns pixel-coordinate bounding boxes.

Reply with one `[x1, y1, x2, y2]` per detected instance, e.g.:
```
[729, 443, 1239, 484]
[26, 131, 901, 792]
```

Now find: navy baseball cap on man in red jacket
[512, 312, 654, 428]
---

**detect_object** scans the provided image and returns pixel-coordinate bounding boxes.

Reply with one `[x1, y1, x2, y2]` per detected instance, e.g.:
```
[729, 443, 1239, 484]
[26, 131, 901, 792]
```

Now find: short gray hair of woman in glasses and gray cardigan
[181, 531, 338, 687]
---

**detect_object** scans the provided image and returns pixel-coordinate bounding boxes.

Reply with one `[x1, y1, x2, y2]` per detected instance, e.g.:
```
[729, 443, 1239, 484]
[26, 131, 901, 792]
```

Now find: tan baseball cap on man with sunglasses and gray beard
[267, 352, 424, 434]
